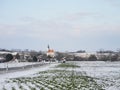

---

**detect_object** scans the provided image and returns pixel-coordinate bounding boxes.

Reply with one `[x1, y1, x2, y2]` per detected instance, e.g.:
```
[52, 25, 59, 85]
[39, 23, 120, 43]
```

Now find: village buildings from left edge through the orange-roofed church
[0, 46, 55, 62]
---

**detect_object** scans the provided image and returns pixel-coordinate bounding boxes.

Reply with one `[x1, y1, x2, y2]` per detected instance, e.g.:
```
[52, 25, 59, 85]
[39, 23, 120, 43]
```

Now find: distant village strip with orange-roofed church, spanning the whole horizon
[0, 45, 120, 62]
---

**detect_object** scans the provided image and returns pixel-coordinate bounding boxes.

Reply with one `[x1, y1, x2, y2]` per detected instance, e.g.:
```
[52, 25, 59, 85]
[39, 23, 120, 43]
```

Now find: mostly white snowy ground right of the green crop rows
[71, 61, 120, 90]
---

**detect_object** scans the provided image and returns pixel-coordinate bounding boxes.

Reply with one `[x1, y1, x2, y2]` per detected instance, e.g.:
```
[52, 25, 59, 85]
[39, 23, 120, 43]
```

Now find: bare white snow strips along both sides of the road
[0, 62, 58, 82]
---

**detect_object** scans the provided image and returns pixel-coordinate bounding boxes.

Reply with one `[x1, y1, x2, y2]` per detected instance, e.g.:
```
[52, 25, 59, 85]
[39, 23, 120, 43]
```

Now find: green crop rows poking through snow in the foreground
[3, 64, 103, 90]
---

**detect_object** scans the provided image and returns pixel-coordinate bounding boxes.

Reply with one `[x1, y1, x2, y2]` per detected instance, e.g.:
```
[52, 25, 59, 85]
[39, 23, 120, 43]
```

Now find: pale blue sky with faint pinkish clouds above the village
[0, 0, 120, 51]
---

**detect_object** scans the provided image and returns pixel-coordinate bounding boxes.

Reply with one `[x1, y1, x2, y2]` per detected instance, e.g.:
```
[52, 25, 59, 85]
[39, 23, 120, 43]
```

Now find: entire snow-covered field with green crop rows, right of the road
[0, 61, 120, 90]
